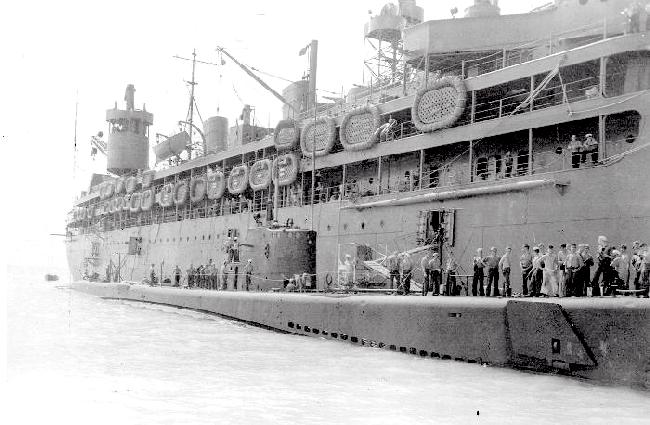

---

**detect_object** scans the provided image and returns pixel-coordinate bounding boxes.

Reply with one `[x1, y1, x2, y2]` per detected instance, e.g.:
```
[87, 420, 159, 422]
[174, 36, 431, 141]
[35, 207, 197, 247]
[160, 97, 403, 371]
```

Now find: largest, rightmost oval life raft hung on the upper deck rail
[411, 76, 467, 132]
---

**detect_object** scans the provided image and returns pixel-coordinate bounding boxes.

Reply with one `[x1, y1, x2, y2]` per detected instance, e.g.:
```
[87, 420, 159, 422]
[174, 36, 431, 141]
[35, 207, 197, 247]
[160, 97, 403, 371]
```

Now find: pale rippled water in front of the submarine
[4, 264, 650, 425]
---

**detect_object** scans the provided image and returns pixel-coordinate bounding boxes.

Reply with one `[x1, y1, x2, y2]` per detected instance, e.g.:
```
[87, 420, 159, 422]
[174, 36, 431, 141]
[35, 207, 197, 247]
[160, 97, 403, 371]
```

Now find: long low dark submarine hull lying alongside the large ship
[72, 281, 650, 389]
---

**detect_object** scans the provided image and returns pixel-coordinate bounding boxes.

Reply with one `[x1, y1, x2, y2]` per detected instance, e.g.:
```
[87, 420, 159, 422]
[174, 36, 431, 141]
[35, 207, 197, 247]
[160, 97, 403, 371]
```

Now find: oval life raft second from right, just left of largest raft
[339, 105, 381, 151]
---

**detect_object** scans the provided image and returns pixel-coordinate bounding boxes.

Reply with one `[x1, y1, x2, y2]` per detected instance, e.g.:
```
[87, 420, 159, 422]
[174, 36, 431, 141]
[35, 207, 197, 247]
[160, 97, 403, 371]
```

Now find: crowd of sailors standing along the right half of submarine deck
[385, 236, 650, 297]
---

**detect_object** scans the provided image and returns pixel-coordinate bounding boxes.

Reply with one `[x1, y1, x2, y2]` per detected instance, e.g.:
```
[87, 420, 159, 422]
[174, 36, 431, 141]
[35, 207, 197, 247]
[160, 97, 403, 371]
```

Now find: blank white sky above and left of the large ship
[0, 0, 546, 264]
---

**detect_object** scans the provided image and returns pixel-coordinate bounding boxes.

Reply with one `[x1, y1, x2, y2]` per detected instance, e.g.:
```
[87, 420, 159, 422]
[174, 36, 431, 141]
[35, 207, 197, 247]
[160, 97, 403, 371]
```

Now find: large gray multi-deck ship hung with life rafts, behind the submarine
[67, 0, 650, 291]
